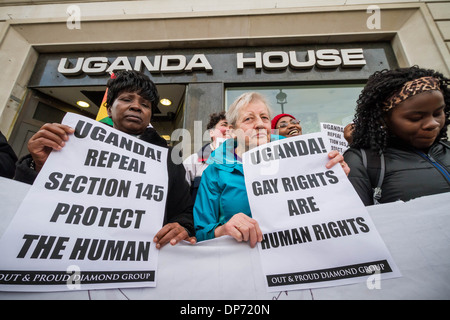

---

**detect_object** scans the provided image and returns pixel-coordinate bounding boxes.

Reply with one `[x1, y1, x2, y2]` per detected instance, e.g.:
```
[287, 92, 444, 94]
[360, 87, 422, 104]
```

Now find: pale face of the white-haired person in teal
[233, 100, 271, 150]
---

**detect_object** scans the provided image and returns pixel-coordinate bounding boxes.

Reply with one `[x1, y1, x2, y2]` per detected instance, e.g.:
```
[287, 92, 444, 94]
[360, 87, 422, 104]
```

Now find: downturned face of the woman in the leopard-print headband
[385, 90, 445, 152]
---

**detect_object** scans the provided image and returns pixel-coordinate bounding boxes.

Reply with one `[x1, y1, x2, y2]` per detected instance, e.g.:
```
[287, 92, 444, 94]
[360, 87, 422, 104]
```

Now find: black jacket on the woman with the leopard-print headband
[344, 141, 450, 206]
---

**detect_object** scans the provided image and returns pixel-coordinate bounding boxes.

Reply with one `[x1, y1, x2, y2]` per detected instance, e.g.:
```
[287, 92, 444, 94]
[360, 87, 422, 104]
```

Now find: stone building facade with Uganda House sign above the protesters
[0, 0, 450, 155]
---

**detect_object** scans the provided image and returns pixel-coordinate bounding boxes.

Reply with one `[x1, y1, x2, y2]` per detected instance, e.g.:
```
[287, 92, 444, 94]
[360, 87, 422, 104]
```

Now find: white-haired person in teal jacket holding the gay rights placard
[194, 92, 350, 248]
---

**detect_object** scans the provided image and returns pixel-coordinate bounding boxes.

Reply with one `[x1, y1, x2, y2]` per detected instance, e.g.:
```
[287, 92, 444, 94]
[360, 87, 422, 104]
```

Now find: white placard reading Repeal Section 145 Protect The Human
[0, 113, 168, 291]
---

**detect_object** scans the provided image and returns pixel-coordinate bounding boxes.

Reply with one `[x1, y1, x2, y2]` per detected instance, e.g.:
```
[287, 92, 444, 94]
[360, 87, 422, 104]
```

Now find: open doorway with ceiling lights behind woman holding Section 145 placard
[9, 84, 186, 158]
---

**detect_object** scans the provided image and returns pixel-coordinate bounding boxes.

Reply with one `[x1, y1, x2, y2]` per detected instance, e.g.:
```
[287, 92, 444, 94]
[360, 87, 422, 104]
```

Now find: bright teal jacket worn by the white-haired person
[194, 135, 284, 241]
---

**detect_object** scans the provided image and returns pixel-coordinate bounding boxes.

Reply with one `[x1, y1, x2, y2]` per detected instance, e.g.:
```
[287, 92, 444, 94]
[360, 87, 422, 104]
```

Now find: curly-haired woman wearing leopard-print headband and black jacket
[344, 66, 450, 205]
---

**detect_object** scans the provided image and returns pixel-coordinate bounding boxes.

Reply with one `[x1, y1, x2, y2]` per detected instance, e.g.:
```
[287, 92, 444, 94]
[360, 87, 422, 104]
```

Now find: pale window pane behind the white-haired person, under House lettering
[225, 84, 364, 134]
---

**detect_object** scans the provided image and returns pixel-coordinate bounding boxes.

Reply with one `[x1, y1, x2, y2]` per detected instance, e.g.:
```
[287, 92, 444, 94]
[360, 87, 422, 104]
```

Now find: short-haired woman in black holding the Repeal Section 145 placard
[15, 71, 196, 248]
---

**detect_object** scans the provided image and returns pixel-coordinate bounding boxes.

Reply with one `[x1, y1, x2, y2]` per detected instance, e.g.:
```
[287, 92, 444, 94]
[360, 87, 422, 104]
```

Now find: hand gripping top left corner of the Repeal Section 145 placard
[28, 123, 75, 172]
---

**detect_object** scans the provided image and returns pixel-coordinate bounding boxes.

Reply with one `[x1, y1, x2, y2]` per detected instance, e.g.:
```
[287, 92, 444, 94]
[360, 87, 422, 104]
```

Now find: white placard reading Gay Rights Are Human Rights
[243, 133, 400, 291]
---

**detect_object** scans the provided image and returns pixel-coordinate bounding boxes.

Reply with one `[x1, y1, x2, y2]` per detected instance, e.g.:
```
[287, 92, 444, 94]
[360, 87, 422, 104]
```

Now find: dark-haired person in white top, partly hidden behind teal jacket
[183, 111, 229, 201]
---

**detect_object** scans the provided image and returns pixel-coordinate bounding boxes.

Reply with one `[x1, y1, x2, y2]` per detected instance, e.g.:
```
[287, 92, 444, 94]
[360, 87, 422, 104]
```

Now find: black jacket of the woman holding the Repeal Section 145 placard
[14, 128, 195, 236]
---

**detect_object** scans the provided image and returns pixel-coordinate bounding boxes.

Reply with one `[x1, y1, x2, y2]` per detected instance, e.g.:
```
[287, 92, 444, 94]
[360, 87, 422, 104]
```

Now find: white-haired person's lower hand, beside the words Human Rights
[214, 212, 262, 248]
